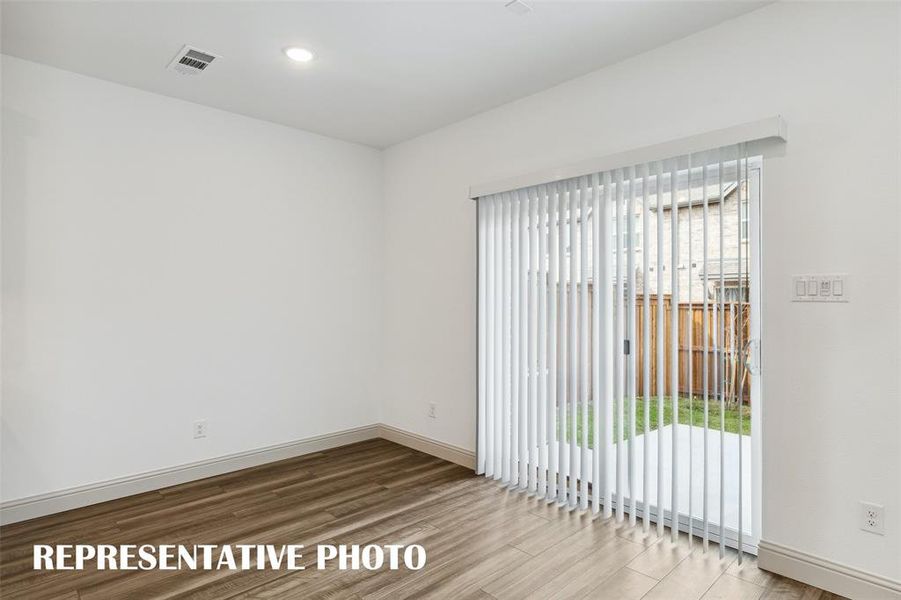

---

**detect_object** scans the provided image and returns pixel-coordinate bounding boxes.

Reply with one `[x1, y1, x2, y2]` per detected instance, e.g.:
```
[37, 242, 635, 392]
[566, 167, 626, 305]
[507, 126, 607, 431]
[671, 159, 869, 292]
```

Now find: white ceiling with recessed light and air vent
[2, 0, 764, 147]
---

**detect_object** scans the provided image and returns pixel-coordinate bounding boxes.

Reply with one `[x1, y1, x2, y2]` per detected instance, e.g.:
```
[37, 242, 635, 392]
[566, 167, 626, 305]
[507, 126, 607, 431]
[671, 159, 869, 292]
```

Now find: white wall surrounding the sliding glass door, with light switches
[383, 3, 901, 580]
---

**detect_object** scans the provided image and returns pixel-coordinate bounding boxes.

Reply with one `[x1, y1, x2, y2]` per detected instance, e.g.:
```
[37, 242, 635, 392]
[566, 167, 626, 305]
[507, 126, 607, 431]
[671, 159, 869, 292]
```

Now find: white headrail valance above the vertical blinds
[469, 115, 788, 200]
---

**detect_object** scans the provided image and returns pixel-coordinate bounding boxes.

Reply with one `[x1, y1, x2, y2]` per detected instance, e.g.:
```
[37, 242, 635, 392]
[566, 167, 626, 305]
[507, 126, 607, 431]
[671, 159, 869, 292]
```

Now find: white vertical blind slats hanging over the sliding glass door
[477, 145, 752, 553]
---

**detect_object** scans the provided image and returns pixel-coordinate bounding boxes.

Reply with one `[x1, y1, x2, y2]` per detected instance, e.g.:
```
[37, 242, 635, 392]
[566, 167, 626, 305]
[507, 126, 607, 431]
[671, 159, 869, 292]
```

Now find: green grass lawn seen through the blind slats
[566, 396, 751, 447]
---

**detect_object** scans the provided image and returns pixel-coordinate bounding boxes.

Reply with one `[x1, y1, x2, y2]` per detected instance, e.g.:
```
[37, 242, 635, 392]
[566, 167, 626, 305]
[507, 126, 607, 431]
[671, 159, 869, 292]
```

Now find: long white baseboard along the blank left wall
[0, 425, 379, 525]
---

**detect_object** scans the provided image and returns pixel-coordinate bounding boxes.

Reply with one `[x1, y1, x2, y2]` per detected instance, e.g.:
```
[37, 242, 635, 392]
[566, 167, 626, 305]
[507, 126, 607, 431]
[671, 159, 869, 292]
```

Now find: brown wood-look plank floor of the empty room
[0, 440, 837, 600]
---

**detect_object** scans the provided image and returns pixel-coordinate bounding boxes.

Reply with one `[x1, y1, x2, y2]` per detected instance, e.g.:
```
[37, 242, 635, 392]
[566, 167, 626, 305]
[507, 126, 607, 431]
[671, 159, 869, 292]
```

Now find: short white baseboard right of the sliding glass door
[757, 540, 901, 600]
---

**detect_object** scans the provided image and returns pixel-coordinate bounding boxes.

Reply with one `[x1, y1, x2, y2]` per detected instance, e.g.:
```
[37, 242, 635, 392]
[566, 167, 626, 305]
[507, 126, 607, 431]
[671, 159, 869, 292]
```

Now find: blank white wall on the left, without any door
[2, 57, 382, 500]
